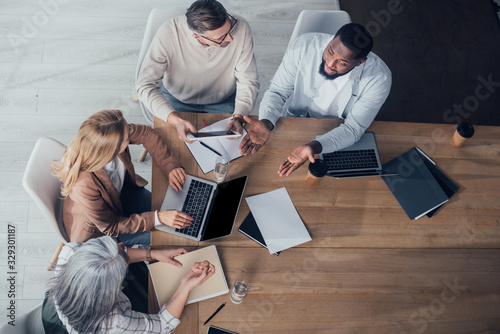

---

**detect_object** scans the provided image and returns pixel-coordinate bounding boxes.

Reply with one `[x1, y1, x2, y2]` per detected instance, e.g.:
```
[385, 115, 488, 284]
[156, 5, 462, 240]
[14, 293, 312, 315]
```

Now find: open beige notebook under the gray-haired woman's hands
[149, 245, 229, 308]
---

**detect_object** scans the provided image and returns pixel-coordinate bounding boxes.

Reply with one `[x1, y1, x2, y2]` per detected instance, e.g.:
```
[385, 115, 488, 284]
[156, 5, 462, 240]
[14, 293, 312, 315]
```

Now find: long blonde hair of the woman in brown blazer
[52, 110, 125, 197]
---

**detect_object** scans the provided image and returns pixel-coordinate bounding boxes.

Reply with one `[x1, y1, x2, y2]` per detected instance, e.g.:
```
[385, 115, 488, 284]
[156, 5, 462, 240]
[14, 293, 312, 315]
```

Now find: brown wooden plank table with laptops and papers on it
[150, 113, 500, 334]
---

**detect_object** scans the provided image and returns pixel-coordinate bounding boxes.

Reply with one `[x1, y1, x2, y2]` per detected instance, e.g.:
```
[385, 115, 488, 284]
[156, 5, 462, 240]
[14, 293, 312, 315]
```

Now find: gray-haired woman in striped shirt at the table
[42, 236, 215, 334]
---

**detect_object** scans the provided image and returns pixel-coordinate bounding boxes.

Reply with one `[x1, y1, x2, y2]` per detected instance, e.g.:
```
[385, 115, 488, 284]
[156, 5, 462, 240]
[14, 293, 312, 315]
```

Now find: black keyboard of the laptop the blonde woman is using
[175, 180, 213, 237]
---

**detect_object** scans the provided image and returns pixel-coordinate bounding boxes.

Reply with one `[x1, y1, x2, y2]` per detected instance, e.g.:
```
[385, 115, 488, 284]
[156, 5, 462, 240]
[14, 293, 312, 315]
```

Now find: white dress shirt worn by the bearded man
[259, 33, 392, 153]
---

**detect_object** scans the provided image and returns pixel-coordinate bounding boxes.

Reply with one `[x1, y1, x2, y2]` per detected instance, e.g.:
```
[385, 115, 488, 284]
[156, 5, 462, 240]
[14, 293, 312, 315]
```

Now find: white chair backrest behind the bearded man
[288, 10, 351, 45]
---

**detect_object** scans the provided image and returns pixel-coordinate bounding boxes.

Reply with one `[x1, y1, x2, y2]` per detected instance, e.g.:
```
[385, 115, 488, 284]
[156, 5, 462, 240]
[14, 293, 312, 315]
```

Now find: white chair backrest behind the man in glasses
[135, 6, 187, 124]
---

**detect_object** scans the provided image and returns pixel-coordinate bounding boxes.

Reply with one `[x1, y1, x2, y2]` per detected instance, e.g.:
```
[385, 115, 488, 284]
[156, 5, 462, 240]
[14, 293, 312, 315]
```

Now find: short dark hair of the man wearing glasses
[186, 0, 227, 34]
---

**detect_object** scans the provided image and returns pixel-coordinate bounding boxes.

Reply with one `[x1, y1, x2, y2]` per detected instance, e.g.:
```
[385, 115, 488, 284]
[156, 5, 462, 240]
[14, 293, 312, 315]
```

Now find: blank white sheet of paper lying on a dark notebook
[245, 188, 311, 254]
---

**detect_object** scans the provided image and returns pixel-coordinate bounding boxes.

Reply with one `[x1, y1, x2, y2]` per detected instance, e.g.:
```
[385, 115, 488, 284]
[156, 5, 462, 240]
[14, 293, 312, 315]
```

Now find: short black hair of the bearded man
[335, 23, 373, 59]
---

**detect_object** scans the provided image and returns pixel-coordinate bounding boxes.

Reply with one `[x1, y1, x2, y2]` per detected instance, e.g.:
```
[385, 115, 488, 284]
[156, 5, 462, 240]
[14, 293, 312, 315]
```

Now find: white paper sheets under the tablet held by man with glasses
[186, 118, 247, 174]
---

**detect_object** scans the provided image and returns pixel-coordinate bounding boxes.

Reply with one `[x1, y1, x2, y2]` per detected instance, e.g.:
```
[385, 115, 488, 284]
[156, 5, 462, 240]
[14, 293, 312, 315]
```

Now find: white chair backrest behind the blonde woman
[23, 137, 69, 243]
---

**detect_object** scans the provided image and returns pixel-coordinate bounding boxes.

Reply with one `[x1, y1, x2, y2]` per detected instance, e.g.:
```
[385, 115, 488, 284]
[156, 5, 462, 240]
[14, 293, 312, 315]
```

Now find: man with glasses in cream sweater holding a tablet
[137, 0, 259, 142]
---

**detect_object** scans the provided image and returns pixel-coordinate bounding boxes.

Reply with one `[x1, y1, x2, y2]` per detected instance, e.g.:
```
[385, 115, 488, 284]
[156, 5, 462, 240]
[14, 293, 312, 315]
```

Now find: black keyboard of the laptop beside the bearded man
[323, 149, 378, 171]
